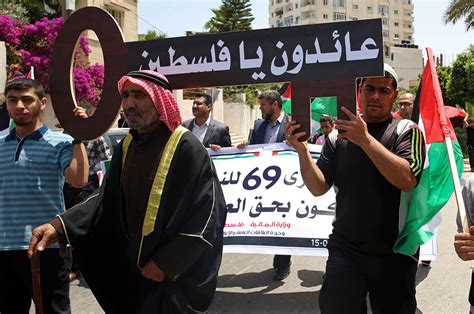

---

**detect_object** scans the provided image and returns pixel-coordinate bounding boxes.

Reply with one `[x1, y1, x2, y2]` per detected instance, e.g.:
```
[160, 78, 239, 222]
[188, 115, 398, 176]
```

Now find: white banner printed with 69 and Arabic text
[209, 143, 436, 260]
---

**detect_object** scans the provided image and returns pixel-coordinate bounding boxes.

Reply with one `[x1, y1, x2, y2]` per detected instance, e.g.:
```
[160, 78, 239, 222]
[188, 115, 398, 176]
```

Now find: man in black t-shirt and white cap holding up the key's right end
[285, 65, 425, 313]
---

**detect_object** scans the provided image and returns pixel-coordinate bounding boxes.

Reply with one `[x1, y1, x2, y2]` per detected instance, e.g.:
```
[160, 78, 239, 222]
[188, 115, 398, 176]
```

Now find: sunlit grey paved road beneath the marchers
[55, 166, 472, 313]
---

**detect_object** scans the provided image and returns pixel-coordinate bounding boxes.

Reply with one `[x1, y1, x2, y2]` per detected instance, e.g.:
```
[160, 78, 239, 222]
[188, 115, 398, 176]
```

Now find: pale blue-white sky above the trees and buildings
[138, 0, 474, 64]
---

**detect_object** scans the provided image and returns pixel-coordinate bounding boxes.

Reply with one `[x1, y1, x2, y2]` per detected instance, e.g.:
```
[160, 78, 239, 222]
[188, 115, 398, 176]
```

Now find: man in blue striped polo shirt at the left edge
[0, 78, 89, 313]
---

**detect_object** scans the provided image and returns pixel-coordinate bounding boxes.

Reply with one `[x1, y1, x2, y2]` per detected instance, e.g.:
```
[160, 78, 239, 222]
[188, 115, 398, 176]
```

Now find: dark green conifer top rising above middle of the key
[204, 0, 254, 33]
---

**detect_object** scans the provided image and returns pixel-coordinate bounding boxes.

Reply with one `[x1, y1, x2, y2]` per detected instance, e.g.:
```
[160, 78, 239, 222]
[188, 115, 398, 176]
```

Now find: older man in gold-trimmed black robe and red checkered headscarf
[29, 71, 226, 313]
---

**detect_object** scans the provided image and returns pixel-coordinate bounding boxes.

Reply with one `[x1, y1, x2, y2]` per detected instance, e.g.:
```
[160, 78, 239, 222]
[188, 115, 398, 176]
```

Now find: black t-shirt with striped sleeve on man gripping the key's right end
[317, 118, 425, 254]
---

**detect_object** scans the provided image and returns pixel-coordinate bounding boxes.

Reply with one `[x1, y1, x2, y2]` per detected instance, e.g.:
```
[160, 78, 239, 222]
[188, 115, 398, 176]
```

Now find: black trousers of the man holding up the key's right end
[319, 241, 418, 314]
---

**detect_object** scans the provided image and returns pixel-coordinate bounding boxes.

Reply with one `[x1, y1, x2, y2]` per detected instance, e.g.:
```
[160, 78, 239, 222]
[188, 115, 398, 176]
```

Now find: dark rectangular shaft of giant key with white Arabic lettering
[127, 19, 383, 89]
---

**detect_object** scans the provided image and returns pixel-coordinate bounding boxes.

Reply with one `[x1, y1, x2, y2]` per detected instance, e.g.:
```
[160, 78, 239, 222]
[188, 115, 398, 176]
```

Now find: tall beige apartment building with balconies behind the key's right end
[268, 0, 423, 89]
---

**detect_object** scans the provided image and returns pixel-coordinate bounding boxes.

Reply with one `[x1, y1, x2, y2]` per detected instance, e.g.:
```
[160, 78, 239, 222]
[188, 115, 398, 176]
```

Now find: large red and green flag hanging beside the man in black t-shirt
[393, 48, 463, 255]
